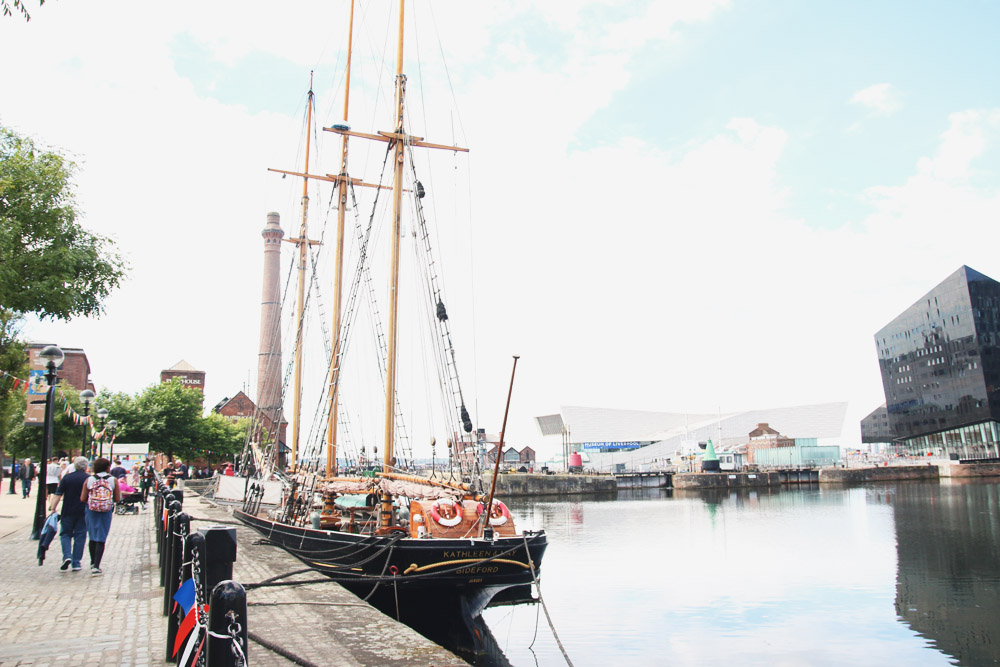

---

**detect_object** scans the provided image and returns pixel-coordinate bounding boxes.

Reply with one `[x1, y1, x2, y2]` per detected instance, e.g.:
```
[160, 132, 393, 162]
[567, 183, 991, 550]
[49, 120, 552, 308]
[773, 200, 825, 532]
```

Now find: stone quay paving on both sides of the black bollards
[0, 485, 466, 667]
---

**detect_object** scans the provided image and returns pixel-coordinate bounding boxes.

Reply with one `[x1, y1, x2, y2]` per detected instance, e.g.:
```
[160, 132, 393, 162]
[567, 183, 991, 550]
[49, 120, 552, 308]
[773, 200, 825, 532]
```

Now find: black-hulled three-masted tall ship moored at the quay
[233, 0, 547, 648]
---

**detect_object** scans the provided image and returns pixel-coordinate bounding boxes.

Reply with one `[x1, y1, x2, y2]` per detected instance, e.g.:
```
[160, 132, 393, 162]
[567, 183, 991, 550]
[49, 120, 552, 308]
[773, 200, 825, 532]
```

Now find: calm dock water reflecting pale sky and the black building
[480, 480, 1000, 667]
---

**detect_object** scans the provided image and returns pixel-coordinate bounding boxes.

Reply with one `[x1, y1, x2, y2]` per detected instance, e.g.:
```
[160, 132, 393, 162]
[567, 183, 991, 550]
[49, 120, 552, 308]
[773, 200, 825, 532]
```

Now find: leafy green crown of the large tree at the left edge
[0, 127, 126, 320]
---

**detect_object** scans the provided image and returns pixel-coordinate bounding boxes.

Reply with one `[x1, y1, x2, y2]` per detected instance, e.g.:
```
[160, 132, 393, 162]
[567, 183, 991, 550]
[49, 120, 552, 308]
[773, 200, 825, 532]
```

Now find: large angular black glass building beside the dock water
[875, 266, 1000, 459]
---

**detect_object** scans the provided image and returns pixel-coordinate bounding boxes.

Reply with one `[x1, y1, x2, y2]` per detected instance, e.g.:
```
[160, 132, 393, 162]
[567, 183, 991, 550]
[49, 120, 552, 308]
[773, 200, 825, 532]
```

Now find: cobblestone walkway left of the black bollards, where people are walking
[0, 488, 167, 667]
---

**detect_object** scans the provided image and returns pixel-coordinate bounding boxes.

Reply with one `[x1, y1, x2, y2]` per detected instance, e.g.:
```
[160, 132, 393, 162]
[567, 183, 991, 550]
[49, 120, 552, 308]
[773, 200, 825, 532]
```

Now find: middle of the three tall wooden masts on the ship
[326, 0, 354, 479]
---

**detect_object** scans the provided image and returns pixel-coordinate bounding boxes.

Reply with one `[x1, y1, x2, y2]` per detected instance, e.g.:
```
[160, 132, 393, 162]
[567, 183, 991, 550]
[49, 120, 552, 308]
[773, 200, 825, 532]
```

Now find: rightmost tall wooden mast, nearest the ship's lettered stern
[379, 0, 406, 528]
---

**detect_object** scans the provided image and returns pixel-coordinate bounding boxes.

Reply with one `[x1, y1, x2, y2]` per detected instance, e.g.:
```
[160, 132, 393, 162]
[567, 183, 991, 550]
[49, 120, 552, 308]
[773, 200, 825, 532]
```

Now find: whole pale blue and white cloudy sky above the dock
[0, 0, 1000, 462]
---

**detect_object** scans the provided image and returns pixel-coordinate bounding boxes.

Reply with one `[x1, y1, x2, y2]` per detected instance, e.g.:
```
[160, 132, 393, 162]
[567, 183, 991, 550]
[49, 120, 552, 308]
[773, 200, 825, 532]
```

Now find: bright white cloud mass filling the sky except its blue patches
[0, 2, 1000, 464]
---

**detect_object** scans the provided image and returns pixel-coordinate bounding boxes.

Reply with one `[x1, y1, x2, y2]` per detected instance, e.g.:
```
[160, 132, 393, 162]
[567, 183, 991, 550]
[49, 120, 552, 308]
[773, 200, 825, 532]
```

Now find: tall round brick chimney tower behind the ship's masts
[257, 213, 285, 420]
